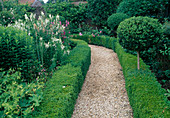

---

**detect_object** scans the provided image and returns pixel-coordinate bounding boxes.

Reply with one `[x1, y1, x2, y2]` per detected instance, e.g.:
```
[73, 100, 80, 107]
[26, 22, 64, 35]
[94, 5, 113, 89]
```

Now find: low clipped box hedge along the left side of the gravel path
[30, 40, 91, 118]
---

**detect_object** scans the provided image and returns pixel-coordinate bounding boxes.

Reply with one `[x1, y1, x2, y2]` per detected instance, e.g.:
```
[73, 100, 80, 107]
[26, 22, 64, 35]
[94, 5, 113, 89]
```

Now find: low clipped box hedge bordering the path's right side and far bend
[73, 35, 170, 118]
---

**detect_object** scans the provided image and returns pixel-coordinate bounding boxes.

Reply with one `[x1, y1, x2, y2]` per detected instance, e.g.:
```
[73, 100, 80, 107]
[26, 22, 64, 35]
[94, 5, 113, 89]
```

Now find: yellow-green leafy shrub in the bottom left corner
[0, 70, 44, 118]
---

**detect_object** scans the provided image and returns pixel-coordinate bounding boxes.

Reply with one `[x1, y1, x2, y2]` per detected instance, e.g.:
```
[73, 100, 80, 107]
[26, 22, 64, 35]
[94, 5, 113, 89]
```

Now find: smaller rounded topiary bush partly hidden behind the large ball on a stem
[107, 13, 129, 30]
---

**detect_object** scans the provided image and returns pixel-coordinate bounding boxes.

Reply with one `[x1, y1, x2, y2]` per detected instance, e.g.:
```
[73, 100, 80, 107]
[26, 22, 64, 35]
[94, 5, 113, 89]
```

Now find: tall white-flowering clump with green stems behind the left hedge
[9, 12, 69, 69]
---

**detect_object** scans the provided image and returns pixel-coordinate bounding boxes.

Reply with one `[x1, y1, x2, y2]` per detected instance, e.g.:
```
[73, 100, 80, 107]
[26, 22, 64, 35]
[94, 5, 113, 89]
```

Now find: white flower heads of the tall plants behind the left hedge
[9, 12, 69, 66]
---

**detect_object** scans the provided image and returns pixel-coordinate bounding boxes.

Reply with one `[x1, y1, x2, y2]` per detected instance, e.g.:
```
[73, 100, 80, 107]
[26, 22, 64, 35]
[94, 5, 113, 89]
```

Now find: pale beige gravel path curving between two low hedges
[72, 45, 133, 118]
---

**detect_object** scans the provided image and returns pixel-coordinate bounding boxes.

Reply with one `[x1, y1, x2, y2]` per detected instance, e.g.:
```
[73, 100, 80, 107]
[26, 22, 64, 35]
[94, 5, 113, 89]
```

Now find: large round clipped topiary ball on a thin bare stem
[117, 16, 163, 69]
